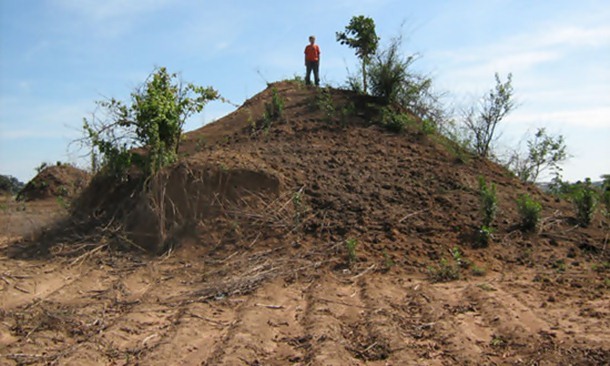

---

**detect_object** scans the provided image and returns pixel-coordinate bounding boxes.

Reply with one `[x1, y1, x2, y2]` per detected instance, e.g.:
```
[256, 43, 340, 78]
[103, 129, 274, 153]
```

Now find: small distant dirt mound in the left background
[17, 164, 90, 201]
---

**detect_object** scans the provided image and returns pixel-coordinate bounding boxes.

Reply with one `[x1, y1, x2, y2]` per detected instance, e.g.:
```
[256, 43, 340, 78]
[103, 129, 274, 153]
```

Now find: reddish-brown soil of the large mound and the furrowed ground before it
[0, 83, 610, 365]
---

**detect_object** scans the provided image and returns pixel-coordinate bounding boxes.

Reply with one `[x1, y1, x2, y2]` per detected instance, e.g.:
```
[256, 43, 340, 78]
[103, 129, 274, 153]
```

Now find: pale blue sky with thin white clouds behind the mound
[0, 0, 610, 181]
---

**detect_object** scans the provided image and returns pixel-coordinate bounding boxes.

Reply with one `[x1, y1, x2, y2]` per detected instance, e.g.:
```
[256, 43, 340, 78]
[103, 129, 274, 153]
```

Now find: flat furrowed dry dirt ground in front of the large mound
[0, 203, 610, 365]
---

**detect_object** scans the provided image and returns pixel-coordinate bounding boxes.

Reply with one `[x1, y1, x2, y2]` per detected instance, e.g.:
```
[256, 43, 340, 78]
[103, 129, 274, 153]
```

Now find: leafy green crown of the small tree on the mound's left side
[83, 67, 220, 178]
